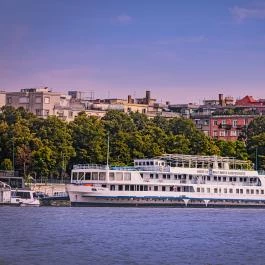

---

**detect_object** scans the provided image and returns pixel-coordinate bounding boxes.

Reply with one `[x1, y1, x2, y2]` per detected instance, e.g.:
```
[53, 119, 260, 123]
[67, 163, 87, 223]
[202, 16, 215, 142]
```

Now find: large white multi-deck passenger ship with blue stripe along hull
[67, 154, 265, 207]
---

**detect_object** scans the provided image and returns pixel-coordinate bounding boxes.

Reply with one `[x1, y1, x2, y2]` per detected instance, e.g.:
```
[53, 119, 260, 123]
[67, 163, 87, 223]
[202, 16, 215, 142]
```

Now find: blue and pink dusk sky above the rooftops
[0, 0, 265, 103]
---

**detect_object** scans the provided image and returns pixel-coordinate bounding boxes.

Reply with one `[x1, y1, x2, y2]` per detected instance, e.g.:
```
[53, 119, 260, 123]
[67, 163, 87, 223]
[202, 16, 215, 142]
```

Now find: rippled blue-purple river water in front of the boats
[0, 207, 265, 265]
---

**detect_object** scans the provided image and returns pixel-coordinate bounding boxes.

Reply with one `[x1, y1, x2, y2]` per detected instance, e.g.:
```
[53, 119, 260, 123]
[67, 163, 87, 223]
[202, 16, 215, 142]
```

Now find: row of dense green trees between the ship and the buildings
[0, 107, 265, 179]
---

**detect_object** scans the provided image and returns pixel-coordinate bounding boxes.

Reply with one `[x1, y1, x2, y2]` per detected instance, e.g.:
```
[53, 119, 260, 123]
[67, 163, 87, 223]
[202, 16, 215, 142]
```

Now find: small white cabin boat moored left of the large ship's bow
[10, 189, 40, 206]
